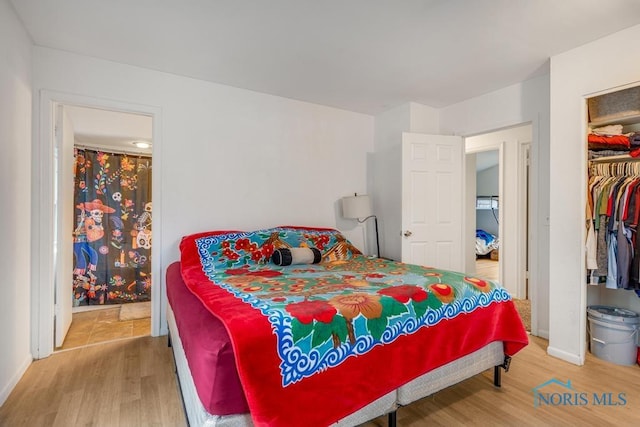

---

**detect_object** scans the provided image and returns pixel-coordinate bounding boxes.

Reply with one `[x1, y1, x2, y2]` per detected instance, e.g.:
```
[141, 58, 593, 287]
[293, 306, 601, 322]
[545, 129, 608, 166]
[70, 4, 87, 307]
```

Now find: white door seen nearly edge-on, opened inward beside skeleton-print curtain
[53, 105, 74, 347]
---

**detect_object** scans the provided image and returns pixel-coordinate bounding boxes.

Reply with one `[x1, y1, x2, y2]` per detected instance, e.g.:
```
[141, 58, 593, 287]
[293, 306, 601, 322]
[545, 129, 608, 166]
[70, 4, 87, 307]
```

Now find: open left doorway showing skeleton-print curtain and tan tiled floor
[53, 104, 153, 351]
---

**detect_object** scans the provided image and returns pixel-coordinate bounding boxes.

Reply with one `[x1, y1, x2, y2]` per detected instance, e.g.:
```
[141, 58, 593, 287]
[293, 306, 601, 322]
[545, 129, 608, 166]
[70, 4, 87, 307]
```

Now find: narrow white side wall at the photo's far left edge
[0, 0, 32, 405]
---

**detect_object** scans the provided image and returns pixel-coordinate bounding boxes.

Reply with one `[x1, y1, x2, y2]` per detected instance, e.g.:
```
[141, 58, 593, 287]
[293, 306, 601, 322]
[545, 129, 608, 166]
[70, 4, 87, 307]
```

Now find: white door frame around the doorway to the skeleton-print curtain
[31, 89, 166, 359]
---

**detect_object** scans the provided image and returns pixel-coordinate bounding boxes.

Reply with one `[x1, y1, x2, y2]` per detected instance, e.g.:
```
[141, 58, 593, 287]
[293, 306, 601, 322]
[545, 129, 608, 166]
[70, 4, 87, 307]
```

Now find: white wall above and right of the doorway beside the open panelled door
[439, 75, 550, 337]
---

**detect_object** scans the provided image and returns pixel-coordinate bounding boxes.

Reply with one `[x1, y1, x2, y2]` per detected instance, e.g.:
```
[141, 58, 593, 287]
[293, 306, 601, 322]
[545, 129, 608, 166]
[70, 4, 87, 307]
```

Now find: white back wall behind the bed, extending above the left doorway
[33, 47, 374, 344]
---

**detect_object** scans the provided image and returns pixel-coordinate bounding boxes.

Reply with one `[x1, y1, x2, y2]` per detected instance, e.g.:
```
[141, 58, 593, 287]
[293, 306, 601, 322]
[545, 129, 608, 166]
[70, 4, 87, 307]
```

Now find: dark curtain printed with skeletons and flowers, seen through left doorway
[73, 148, 152, 306]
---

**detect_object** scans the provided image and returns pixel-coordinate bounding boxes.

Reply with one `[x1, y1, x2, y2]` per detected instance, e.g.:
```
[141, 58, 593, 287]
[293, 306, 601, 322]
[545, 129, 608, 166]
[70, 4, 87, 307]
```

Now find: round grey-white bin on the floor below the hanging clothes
[587, 305, 640, 365]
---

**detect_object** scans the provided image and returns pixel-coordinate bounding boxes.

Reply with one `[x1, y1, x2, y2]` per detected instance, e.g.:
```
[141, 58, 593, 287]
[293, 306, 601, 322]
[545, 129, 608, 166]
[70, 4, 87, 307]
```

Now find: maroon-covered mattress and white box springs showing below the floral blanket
[166, 262, 504, 427]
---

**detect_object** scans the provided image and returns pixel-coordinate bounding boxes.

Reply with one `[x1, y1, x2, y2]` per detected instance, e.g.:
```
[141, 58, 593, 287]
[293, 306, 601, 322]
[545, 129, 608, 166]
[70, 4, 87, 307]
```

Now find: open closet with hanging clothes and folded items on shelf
[585, 86, 640, 312]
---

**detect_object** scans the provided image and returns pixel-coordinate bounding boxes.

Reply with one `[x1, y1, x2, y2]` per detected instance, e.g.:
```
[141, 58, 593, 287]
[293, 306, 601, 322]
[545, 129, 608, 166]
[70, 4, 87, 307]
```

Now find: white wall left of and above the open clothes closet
[548, 25, 640, 364]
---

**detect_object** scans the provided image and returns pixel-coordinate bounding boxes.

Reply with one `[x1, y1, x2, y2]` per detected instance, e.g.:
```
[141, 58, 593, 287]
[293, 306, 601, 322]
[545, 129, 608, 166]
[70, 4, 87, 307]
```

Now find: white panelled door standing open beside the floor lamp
[402, 133, 464, 271]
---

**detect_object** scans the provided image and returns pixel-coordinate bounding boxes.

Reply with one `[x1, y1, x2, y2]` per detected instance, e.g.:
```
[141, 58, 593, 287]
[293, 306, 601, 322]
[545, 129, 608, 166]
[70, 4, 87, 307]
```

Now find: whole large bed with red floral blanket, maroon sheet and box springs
[166, 227, 527, 426]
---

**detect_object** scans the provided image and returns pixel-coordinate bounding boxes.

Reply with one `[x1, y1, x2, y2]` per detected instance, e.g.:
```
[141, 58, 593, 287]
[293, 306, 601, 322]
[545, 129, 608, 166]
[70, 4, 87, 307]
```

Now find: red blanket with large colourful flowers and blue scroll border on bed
[181, 227, 527, 425]
